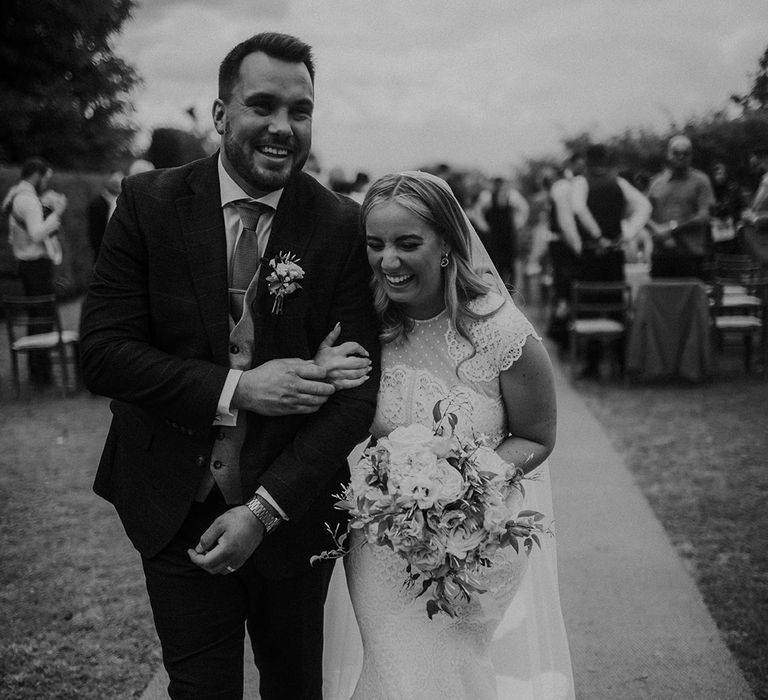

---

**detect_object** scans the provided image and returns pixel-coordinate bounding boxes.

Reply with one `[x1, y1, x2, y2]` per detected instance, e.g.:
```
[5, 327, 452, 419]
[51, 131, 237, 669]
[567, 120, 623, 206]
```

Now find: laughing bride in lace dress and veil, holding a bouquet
[316, 172, 574, 700]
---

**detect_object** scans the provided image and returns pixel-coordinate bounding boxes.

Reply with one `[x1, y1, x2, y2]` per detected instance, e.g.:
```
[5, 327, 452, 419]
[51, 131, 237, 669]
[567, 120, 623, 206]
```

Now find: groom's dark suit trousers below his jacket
[142, 487, 334, 700]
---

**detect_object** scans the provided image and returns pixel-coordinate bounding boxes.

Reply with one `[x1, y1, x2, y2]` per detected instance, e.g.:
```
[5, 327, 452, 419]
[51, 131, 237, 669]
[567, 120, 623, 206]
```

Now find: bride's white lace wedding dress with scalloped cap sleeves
[325, 293, 573, 700]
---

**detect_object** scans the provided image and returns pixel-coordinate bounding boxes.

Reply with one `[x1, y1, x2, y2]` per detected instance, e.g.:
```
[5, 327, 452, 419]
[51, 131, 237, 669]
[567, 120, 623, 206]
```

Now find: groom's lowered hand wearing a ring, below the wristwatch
[187, 506, 264, 574]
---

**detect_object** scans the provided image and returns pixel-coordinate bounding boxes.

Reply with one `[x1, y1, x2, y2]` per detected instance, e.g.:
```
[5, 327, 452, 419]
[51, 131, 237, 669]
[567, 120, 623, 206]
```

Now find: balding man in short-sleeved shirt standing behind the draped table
[648, 135, 715, 278]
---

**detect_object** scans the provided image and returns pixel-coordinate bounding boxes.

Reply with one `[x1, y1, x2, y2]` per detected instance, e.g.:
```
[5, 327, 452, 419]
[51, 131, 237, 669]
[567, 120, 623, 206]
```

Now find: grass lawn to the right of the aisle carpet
[576, 363, 768, 700]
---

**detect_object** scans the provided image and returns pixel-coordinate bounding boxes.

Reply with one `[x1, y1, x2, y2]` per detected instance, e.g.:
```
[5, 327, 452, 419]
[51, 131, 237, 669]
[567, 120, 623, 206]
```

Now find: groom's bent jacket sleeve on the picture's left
[81, 171, 228, 435]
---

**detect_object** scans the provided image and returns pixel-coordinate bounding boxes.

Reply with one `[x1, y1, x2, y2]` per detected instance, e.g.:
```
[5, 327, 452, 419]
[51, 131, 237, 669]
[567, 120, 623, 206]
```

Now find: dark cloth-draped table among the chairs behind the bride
[626, 278, 713, 382]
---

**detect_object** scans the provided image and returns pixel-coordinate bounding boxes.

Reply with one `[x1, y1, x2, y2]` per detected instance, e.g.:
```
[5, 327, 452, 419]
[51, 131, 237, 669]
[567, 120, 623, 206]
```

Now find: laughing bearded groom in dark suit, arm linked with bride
[81, 33, 379, 700]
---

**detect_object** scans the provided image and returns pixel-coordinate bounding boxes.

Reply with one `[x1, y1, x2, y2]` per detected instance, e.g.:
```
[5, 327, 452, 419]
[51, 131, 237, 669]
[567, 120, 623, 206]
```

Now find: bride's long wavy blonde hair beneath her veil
[360, 171, 495, 347]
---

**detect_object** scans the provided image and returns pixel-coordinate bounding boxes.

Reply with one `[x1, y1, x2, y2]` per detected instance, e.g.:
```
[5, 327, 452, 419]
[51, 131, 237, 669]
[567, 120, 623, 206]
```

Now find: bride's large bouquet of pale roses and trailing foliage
[312, 402, 546, 619]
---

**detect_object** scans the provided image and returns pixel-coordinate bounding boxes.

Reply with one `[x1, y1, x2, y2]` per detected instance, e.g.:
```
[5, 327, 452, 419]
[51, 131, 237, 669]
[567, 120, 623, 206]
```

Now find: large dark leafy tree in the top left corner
[0, 0, 140, 169]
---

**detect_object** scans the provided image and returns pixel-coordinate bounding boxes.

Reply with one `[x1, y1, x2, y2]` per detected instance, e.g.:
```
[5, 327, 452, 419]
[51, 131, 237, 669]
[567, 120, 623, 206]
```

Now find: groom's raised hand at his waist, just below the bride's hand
[231, 358, 335, 416]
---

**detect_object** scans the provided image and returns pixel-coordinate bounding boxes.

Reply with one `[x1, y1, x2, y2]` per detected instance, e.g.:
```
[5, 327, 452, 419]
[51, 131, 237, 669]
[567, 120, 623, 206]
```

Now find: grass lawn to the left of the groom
[0, 393, 160, 700]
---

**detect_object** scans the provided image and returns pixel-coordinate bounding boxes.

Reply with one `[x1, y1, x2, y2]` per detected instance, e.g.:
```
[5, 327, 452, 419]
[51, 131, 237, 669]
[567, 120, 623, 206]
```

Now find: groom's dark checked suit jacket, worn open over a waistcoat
[81, 155, 380, 578]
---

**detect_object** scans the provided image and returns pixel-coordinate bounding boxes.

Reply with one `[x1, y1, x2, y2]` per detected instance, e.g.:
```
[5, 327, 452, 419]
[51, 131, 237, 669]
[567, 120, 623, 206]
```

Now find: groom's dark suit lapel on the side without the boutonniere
[176, 155, 229, 366]
